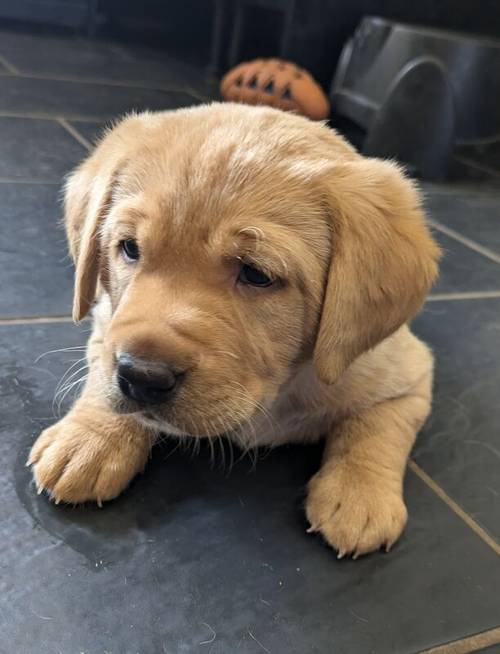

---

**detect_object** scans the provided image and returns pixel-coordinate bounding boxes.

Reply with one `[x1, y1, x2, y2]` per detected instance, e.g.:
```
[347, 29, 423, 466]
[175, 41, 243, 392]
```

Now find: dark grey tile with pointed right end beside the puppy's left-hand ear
[0, 117, 86, 182]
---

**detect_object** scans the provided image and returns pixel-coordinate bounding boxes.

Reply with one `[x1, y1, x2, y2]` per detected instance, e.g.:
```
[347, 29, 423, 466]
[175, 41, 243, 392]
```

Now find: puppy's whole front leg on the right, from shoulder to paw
[306, 375, 431, 558]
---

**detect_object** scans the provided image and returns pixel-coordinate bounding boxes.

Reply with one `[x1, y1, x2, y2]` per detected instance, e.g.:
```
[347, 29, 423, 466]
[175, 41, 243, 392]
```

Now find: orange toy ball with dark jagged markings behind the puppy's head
[220, 59, 330, 120]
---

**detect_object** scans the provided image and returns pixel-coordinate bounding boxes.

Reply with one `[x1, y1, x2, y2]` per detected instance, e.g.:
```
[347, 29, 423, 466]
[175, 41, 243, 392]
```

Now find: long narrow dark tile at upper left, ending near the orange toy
[0, 77, 199, 121]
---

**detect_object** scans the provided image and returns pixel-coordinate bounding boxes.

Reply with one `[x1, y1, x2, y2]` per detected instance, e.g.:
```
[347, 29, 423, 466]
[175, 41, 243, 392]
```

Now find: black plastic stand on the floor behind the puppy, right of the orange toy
[331, 17, 500, 179]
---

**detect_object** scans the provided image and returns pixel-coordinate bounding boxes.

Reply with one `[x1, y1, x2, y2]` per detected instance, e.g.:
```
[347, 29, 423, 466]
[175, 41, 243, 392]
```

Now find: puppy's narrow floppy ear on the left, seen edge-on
[64, 148, 118, 322]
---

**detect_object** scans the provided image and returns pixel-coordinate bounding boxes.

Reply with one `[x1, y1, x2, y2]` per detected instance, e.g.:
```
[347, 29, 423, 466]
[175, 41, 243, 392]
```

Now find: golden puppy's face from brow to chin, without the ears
[101, 147, 329, 435]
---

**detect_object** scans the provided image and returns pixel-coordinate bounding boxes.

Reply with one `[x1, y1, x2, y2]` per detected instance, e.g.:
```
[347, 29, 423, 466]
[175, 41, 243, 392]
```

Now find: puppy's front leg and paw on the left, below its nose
[27, 332, 154, 504]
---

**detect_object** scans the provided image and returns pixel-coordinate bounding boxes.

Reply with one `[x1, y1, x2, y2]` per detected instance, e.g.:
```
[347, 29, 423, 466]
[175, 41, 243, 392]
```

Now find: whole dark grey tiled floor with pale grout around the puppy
[0, 25, 500, 654]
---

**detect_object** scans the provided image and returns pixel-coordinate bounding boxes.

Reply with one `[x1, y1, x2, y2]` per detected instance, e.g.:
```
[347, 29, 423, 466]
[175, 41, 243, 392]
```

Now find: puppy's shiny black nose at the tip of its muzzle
[117, 354, 179, 404]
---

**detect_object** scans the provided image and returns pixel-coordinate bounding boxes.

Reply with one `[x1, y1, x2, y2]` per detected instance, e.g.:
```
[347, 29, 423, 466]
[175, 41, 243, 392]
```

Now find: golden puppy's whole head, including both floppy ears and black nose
[66, 104, 438, 436]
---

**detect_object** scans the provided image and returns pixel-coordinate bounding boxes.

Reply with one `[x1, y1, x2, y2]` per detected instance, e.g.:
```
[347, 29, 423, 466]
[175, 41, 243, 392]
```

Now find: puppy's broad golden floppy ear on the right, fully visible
[314, 158, 440, 384]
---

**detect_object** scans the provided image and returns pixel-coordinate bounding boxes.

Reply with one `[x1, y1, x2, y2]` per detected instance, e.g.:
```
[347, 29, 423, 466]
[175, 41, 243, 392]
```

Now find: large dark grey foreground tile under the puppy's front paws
[0, 324, 500, 654]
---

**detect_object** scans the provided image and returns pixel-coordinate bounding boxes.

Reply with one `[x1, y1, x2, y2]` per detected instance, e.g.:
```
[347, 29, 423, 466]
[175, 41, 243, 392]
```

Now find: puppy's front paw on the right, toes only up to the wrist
[306, 464, 408, 559]
